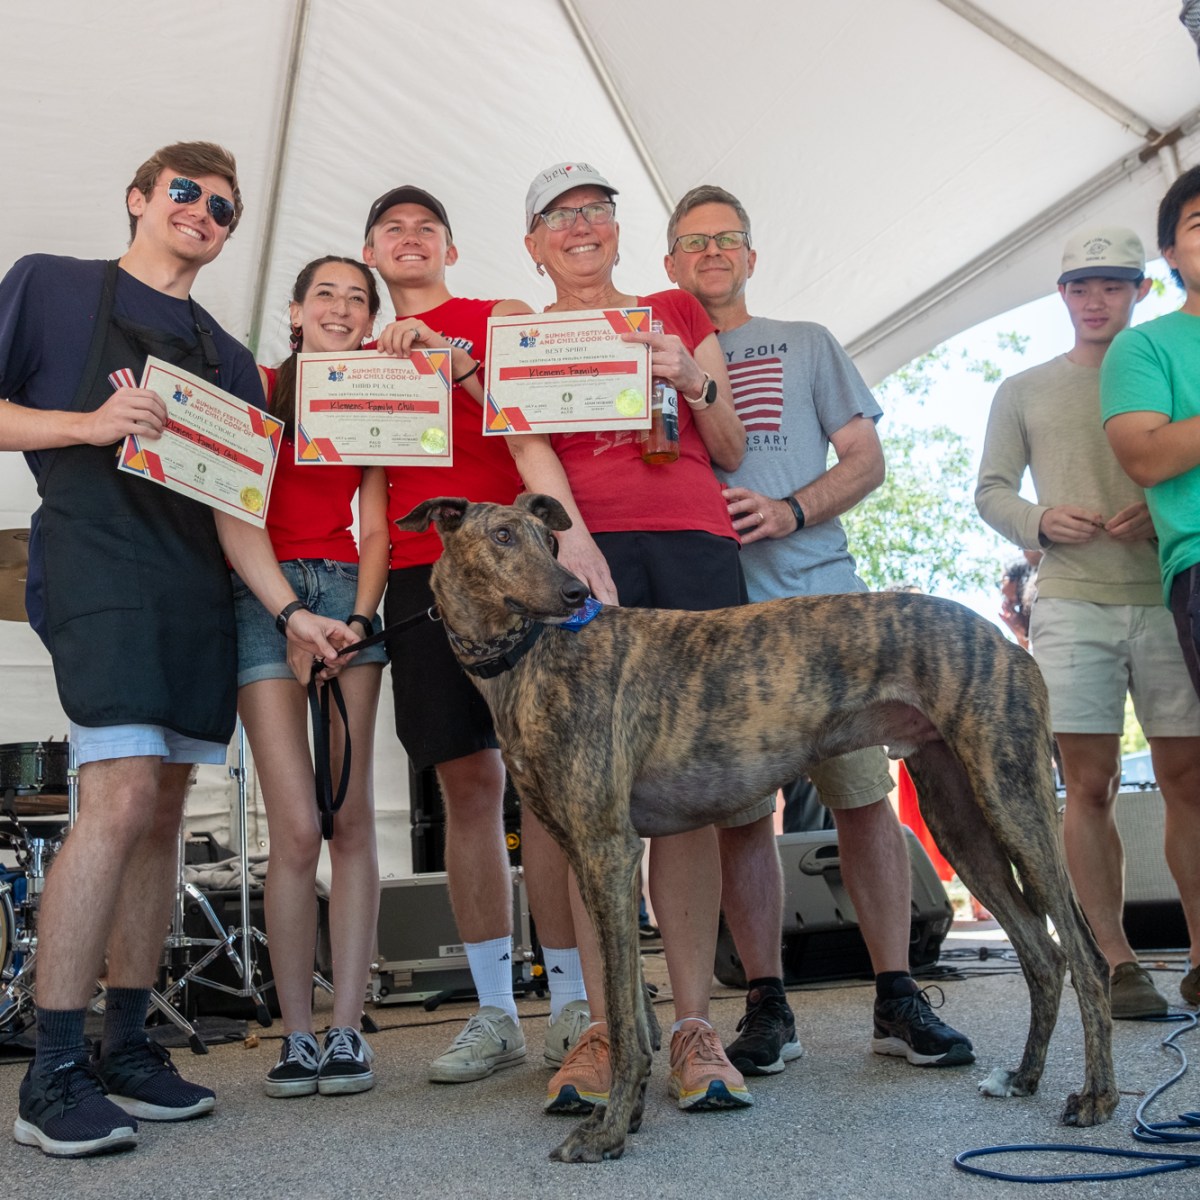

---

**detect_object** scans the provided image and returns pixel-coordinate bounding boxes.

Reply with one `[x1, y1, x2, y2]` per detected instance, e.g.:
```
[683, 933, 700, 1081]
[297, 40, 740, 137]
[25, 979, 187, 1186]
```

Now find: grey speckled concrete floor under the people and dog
[0, 923, 1200, 1200]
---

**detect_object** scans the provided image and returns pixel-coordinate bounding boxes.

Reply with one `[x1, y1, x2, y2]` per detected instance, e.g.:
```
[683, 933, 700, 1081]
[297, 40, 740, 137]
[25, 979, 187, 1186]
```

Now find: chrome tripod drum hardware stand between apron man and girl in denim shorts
[162, 720, 334, 1028]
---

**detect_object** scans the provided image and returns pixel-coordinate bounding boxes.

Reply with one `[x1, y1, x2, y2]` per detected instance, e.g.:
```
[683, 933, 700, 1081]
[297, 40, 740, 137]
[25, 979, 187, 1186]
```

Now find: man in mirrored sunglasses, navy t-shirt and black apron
[0, 142, 355, 1157]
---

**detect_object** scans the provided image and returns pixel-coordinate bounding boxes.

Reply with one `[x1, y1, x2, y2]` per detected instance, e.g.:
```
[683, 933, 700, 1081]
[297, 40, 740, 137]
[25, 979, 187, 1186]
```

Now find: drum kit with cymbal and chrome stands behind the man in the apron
[0, 529, 290, 1054]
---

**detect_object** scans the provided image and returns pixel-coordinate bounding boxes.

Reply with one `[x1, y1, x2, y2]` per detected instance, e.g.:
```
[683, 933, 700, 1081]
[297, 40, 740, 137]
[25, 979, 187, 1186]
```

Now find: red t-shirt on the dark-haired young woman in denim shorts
[263, 367, 362, 563]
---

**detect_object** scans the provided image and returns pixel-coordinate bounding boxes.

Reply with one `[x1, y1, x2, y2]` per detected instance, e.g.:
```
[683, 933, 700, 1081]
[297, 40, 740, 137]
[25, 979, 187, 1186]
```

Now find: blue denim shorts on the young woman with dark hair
[229, 558, 388, 688]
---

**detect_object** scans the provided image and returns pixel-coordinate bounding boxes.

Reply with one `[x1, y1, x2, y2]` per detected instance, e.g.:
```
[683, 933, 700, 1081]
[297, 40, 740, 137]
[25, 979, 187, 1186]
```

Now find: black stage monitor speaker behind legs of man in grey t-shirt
[714, 829, 954, 988]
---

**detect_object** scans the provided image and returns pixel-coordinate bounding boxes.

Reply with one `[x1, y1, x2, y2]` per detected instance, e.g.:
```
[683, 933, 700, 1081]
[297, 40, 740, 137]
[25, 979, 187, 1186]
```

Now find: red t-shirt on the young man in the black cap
[386, 296, 522, 570]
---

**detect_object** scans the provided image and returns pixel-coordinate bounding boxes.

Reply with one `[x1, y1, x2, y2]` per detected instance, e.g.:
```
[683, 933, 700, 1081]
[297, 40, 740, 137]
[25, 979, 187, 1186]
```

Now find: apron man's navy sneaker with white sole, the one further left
[12, 1062, 138, 1158]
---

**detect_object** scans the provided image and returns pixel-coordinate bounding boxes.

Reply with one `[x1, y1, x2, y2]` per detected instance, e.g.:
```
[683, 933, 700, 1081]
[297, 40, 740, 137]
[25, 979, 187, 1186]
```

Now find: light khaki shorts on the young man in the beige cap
[1030, 598, 1200, 738]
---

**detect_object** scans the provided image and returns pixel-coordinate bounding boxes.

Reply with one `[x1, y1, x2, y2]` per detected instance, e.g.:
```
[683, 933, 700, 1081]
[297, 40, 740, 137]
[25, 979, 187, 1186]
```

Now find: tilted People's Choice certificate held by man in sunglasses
[116, 356, 283, 528]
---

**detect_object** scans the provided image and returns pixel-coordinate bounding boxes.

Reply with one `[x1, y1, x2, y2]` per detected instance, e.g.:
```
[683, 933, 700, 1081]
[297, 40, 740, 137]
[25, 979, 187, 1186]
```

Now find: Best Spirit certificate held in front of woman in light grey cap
[484, 308, 650, 434]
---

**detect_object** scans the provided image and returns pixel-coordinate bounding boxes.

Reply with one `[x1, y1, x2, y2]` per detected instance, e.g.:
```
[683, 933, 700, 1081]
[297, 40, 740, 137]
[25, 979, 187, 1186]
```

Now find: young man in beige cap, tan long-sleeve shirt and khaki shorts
[976, 228, 1200, 1018]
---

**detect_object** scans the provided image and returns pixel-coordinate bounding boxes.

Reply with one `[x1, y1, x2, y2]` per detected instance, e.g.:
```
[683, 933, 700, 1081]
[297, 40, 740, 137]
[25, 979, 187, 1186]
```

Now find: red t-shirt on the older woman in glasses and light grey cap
[551, 288, 736, 540]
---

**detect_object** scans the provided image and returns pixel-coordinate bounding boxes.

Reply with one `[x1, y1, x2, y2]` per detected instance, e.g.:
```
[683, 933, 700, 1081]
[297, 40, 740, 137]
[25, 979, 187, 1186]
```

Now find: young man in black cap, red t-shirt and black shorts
[362, 185, 589, 1084]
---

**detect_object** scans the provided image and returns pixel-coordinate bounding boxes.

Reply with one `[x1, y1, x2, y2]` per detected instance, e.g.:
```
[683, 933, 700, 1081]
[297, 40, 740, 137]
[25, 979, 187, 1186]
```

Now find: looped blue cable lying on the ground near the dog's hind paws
[954, 1013, 1200, 1183]
